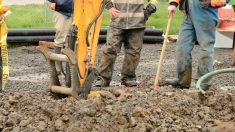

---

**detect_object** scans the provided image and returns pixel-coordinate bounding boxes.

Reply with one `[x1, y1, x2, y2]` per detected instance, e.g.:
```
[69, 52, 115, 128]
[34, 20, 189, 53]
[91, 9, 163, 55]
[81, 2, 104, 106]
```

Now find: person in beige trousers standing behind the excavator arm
[48, 0, 73, 74]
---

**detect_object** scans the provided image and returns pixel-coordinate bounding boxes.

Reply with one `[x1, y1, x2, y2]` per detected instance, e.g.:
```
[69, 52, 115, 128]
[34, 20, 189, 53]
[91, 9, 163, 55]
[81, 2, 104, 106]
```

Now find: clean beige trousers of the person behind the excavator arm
[53, 11, 72, 48]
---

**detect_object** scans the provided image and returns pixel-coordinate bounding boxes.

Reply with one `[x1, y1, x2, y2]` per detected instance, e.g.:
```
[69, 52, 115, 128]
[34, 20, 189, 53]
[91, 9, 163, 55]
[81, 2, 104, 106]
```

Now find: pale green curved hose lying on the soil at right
[196, 68, 235, 94]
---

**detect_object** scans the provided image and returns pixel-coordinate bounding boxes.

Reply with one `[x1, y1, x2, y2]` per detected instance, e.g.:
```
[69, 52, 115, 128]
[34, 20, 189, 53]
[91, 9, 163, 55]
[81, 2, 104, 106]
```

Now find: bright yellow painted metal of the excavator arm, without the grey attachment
[73, 0, 102, 87]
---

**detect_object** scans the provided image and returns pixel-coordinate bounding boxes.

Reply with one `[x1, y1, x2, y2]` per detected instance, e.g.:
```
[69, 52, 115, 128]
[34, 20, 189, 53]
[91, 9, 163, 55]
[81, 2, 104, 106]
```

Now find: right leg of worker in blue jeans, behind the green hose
[194, 5, 216, 90]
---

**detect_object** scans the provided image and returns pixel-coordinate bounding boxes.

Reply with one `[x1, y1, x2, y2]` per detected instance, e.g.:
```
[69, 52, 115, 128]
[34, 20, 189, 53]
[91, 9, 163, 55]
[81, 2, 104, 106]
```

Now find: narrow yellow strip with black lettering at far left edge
[0, 0, 9, 90]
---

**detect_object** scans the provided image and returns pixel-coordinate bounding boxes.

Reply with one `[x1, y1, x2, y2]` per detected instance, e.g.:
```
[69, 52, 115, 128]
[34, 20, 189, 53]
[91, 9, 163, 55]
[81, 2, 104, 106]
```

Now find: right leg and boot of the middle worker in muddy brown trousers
[121, 28, 144, 86]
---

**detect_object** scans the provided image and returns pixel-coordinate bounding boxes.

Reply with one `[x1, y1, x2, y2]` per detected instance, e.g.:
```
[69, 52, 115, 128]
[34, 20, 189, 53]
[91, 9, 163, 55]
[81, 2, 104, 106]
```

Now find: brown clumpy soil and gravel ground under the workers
[0, 43, 235, 132]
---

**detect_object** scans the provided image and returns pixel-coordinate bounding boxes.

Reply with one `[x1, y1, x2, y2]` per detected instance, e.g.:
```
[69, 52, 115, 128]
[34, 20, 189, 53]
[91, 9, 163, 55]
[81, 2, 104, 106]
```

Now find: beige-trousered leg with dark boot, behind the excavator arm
[54, 11, 72, 74]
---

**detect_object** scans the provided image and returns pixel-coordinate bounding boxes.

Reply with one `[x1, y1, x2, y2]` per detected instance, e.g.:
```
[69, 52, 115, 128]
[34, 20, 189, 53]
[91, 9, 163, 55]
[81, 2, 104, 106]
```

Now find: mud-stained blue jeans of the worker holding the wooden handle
[177, 13, 215, 87]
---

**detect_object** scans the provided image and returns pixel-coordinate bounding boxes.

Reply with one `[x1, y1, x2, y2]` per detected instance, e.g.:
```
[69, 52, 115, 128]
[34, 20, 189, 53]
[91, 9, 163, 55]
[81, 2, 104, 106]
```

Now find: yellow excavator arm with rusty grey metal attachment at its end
[37, 0, 106, 99]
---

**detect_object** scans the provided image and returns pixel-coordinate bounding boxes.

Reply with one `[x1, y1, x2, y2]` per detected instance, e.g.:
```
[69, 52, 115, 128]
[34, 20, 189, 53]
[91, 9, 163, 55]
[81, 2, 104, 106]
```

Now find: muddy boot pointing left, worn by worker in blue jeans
[161, 78, 190, 89]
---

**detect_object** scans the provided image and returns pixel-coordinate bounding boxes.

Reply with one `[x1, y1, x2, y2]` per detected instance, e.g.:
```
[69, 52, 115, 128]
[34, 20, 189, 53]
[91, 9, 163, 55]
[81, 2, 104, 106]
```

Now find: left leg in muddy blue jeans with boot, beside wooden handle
[166, 18, 196, 88]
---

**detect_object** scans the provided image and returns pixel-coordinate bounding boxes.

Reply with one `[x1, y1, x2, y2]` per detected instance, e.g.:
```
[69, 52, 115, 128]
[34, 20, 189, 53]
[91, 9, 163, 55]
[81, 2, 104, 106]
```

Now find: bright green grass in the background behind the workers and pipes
[7, 1, 183, 34]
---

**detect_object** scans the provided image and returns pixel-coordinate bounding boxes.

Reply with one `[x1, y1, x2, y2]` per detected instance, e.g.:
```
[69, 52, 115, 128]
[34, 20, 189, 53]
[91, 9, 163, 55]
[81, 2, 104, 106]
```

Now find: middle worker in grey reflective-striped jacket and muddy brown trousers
[95, 0, 156, 87]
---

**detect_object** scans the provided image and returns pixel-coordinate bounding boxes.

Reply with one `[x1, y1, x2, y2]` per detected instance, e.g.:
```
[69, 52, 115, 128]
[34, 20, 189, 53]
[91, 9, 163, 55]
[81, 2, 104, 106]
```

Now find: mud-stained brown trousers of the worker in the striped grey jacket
[97, 27, 144, 81]
